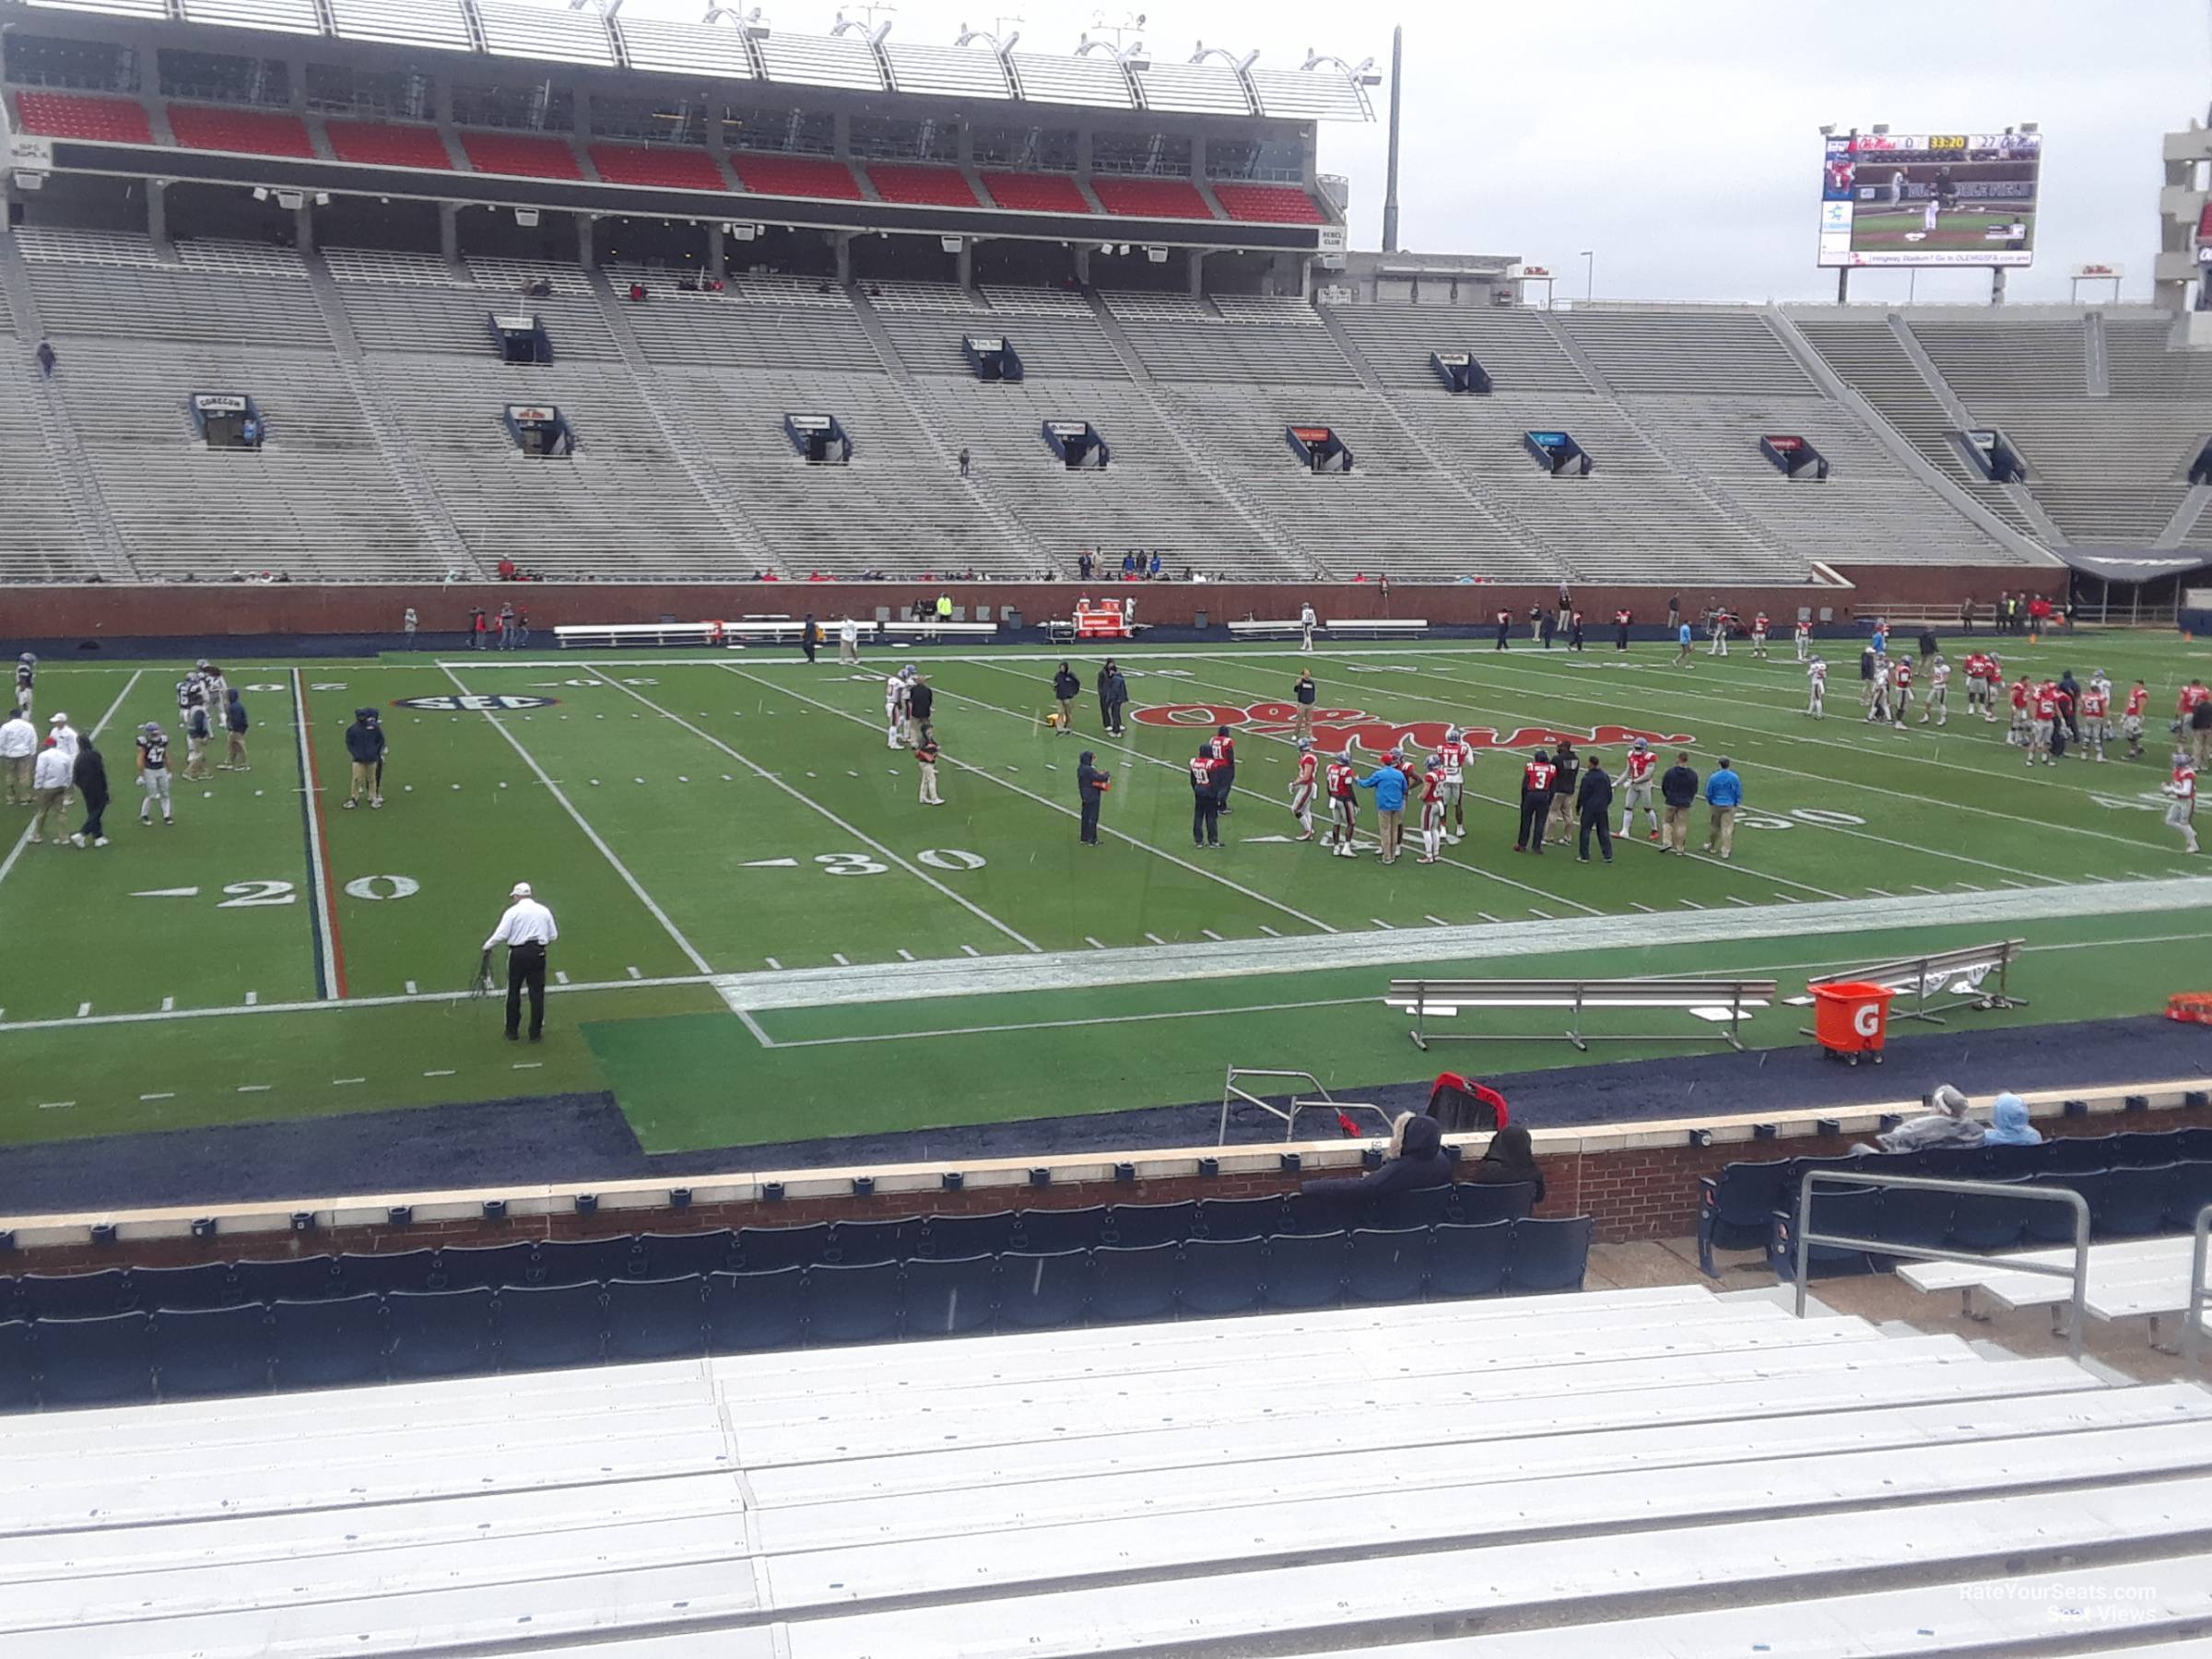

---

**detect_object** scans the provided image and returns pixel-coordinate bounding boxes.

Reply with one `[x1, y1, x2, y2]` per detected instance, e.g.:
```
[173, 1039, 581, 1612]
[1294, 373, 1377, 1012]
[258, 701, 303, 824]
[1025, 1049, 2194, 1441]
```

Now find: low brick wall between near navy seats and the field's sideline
[21, 1106, 2212, 1272]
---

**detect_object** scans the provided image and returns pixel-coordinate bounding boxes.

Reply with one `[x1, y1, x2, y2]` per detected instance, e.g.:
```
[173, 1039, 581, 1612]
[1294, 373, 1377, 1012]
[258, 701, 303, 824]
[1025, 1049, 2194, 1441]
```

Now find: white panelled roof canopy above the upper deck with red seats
[0, 0, 1373, 122]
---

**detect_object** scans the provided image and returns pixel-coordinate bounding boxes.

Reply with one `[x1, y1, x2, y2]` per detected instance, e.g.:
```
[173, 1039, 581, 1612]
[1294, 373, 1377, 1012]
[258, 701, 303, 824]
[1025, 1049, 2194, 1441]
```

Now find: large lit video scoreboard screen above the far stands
[1820, 131, 2044, 267]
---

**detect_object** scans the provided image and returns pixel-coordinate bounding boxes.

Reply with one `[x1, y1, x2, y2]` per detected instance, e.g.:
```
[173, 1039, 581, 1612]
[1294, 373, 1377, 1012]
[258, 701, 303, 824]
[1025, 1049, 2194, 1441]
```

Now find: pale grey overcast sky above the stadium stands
[629, 0, 2212, 300]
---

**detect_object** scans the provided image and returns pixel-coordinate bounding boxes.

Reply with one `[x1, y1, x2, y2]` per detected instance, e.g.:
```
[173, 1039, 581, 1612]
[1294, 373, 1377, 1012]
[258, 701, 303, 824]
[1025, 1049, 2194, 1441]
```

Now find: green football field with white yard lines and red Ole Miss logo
[0, 635, 2212, 1188]
